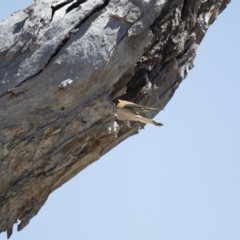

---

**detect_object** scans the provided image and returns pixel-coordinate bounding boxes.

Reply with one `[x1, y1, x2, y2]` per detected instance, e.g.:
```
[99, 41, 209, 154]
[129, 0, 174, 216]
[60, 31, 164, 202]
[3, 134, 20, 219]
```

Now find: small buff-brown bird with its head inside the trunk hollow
[115, 99, 163, 127]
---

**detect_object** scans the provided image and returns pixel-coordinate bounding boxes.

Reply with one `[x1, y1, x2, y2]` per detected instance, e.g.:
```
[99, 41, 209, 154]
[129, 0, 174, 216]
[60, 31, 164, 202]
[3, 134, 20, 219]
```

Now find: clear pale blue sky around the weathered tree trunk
[0, 0, 240, 240]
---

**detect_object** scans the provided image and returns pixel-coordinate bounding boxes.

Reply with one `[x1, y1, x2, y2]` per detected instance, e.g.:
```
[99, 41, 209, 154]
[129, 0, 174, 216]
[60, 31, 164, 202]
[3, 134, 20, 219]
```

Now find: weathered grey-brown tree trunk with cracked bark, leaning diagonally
[0, 0, 230, 236]
